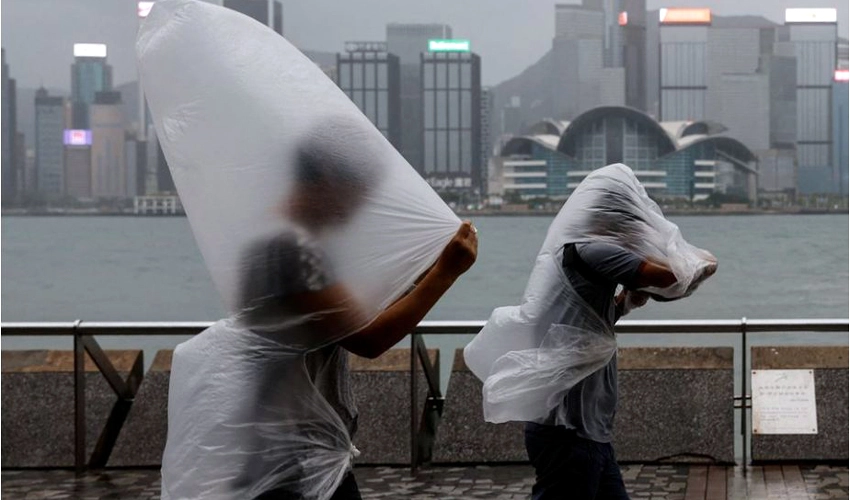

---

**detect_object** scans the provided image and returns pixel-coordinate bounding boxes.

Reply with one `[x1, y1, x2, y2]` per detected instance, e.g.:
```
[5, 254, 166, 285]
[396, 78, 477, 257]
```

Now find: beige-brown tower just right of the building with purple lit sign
[91, 92, 128, 198]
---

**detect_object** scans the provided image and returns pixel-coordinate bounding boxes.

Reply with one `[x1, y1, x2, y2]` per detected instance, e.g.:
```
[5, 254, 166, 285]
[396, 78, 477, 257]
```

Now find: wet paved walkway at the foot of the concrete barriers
[0, 465, 848, 500]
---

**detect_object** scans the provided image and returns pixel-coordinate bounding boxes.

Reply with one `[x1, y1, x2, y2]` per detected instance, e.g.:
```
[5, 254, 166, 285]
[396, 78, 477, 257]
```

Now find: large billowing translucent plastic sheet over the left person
[136, 0, 460, 499]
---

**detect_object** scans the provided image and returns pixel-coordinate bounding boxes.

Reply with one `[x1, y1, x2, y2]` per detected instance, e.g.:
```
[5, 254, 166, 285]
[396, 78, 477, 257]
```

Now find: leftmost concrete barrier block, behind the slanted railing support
[0, 350, 142, 468]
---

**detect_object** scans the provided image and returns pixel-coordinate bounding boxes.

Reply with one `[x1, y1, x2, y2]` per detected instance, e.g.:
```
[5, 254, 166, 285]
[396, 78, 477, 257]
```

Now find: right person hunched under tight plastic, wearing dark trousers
[466, 165, 717, 500]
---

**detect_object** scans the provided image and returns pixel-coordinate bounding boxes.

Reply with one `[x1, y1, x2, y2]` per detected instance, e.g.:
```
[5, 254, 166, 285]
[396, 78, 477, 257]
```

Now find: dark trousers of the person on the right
[525, 423, 629, 500]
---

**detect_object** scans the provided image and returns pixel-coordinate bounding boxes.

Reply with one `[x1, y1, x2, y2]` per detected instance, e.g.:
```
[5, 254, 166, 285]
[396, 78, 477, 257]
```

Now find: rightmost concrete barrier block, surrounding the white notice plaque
[751, 346, 848, 463]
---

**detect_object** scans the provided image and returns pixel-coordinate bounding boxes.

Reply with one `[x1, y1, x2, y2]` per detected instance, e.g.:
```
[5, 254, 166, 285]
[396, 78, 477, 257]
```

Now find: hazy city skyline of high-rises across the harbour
[4, 0, 847, 203]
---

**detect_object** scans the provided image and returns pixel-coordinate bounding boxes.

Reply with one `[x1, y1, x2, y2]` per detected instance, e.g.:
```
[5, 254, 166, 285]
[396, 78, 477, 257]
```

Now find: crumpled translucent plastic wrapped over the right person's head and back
[464, 164, 716, 424]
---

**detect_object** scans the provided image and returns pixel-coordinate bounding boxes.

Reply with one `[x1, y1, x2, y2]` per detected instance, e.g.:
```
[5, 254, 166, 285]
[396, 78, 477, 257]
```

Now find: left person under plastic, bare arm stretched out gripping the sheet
[163, 122, 478, 500]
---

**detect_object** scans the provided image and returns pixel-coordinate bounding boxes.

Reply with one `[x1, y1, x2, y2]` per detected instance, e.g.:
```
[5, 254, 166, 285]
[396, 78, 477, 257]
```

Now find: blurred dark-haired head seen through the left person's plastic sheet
[285, 116, 381, 231]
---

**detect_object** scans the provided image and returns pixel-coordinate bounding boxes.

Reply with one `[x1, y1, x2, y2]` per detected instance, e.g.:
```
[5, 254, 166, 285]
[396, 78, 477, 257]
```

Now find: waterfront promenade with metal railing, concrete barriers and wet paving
[0, 319, 848, 500]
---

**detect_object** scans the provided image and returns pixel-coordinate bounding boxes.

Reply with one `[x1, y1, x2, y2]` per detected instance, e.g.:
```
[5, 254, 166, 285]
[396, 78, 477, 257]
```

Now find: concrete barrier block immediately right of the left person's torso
[350, 349, 440, 464]
